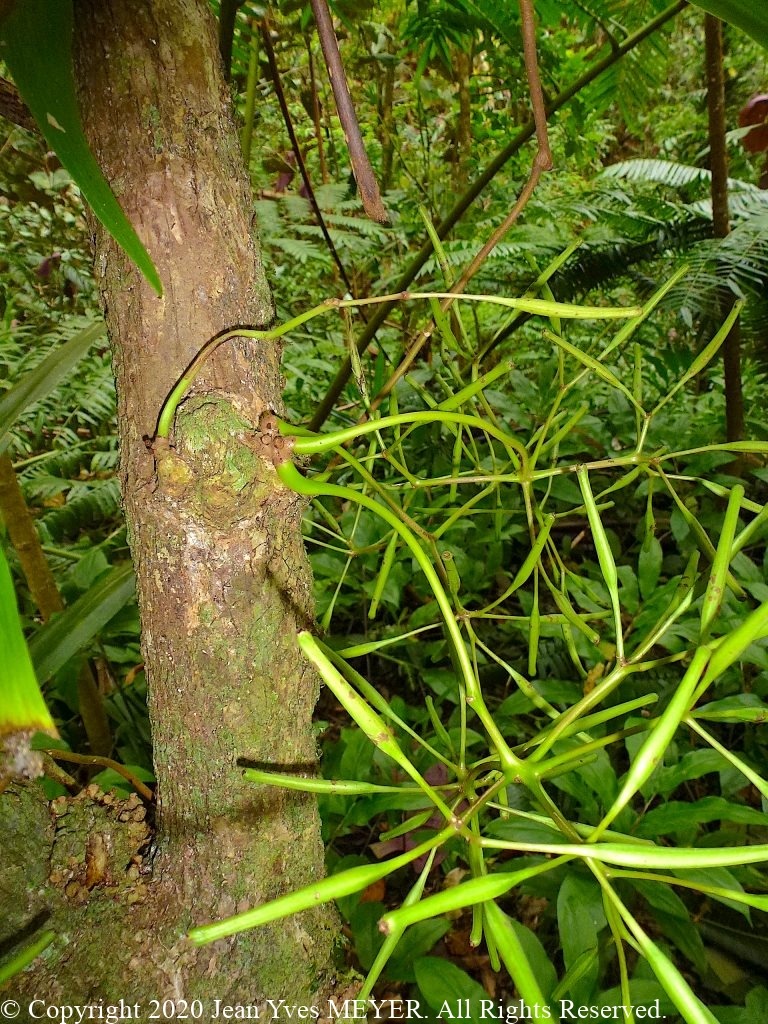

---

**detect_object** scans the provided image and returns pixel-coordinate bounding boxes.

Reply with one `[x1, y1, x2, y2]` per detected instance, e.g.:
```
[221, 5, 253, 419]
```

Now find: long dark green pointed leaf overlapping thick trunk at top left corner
[0, 0, 163, 295]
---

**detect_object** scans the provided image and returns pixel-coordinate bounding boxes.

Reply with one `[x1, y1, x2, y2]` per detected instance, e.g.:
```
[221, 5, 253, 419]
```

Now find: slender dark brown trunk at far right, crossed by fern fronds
[705, 14, 744, 441]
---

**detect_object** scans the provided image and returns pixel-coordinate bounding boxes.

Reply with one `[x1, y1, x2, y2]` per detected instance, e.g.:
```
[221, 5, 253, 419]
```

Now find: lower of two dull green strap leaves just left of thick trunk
[30, 563, 135, 680]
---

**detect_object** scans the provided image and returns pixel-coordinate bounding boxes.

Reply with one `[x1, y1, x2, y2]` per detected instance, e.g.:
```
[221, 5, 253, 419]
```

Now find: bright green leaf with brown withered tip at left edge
[0, 548, 57, 736]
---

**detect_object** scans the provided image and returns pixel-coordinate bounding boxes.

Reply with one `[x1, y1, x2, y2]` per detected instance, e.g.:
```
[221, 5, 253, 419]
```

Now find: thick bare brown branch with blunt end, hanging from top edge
[312, 0, 389, 224]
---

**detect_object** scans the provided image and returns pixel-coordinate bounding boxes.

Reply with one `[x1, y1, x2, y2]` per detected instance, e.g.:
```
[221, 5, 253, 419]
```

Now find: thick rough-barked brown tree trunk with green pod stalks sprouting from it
[9, 0, 334, 1014]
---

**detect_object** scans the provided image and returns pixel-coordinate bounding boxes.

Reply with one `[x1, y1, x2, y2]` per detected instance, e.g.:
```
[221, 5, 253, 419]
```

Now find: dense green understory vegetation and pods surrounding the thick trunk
[0, 0, 768, 1024]
